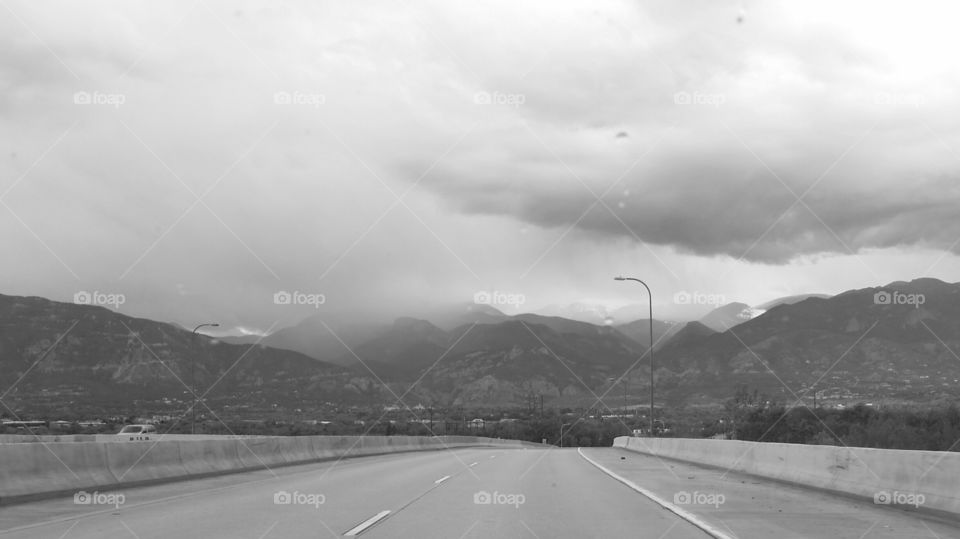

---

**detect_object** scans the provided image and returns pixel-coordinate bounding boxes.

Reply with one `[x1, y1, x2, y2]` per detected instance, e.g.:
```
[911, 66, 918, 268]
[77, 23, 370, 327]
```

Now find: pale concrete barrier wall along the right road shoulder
[614, 436, 960, 518]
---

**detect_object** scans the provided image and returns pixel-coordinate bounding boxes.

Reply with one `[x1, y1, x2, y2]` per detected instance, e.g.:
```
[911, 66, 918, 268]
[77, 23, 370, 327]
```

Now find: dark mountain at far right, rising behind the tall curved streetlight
[637, 279, 960, 408]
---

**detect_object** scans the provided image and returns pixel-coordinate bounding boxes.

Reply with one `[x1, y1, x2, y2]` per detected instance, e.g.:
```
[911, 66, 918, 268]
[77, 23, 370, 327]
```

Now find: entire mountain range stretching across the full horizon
[0, 279, 960, 409]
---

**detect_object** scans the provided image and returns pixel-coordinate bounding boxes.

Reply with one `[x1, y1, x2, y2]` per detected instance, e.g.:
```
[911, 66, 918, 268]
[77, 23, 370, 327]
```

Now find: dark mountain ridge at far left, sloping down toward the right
[0, 295, 356, 418]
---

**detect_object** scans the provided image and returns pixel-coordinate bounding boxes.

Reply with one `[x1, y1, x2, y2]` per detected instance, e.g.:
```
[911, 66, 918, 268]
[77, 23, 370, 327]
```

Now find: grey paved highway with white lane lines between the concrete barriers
[0, 448, 960, 539]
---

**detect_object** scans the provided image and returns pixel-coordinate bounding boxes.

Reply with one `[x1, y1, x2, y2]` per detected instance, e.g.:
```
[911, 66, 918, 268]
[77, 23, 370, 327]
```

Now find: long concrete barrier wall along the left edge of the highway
[0, 436, 540, 505]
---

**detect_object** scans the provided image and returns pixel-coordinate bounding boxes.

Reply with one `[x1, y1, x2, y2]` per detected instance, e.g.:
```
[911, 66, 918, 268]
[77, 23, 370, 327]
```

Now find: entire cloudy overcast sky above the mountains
[0, 0, 960, 331]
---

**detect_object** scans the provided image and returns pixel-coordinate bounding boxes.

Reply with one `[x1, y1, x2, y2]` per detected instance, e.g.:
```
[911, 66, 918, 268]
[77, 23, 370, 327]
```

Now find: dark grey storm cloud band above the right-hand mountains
[416, 130, 960, 263]
